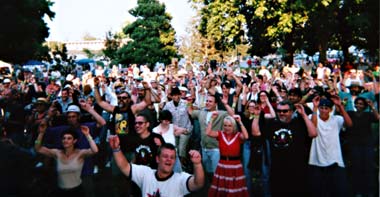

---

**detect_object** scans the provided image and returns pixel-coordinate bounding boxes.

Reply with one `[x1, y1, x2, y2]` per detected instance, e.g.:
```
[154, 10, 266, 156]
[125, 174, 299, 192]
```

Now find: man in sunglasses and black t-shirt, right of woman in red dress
[252, 100, 317, 197]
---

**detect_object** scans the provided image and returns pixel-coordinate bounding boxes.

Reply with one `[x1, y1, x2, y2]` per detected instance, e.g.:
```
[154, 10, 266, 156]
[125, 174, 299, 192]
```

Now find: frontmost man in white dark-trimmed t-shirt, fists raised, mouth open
[109, 139, 204, 196]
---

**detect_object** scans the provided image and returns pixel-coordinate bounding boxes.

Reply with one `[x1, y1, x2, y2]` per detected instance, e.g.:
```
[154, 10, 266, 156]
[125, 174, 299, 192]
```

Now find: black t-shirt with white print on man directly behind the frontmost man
[135, 133, 165, 169]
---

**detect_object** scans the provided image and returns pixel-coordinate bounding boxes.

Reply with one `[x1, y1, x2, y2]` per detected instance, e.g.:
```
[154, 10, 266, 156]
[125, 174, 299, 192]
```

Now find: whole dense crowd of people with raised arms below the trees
[0, 59, 380, 197]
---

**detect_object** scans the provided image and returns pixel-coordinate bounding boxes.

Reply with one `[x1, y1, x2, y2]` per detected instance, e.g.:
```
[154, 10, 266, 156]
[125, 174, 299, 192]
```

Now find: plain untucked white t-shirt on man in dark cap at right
[309, 115, 344, 168]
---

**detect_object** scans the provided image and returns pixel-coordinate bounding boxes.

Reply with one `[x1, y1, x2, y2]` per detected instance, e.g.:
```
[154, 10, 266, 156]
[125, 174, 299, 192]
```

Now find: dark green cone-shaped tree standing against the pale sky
[118, 0, 178, 66]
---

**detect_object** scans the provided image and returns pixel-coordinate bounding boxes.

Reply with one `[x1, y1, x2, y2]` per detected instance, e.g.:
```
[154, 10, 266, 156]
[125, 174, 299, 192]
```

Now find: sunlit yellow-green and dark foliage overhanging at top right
[192, 0, 379, 63]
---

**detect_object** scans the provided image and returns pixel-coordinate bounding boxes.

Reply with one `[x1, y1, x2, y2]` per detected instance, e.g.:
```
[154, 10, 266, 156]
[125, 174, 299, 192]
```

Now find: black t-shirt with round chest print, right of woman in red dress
[260, 114, 311, 187]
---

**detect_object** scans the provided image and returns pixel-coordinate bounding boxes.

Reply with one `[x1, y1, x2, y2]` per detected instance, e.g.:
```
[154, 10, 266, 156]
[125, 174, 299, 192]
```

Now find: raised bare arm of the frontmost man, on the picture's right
[187, 150, 205, 191]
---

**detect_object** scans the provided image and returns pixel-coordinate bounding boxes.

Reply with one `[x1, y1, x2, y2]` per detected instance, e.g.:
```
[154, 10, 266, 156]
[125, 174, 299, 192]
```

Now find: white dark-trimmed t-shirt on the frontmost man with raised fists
[131, 164, 191, 197]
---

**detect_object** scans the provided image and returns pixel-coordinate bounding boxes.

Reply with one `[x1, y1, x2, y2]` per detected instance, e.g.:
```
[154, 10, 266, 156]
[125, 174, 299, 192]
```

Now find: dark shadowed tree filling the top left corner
[0, 0, 55, 64]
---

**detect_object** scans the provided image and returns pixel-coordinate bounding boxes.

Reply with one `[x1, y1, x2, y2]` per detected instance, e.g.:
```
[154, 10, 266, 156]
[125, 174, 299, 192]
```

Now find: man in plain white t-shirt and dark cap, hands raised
[309, 96, 352, 197]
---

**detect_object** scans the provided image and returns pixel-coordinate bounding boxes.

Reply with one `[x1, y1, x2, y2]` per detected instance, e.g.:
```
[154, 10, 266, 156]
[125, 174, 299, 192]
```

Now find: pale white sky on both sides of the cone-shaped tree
[45, 0, 195, 41]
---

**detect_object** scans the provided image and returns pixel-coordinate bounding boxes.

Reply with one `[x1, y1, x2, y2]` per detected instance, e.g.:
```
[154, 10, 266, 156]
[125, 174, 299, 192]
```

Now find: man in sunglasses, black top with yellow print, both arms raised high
[94, 77, 151, 196]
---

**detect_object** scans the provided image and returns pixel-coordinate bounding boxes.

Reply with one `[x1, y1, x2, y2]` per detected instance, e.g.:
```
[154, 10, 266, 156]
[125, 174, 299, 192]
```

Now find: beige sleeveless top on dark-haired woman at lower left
[57, 153, 84, 189]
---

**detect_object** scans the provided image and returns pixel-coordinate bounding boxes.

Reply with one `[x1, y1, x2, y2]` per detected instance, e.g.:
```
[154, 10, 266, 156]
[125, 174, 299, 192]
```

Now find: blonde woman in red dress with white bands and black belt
[206, 113, 248, 197]
